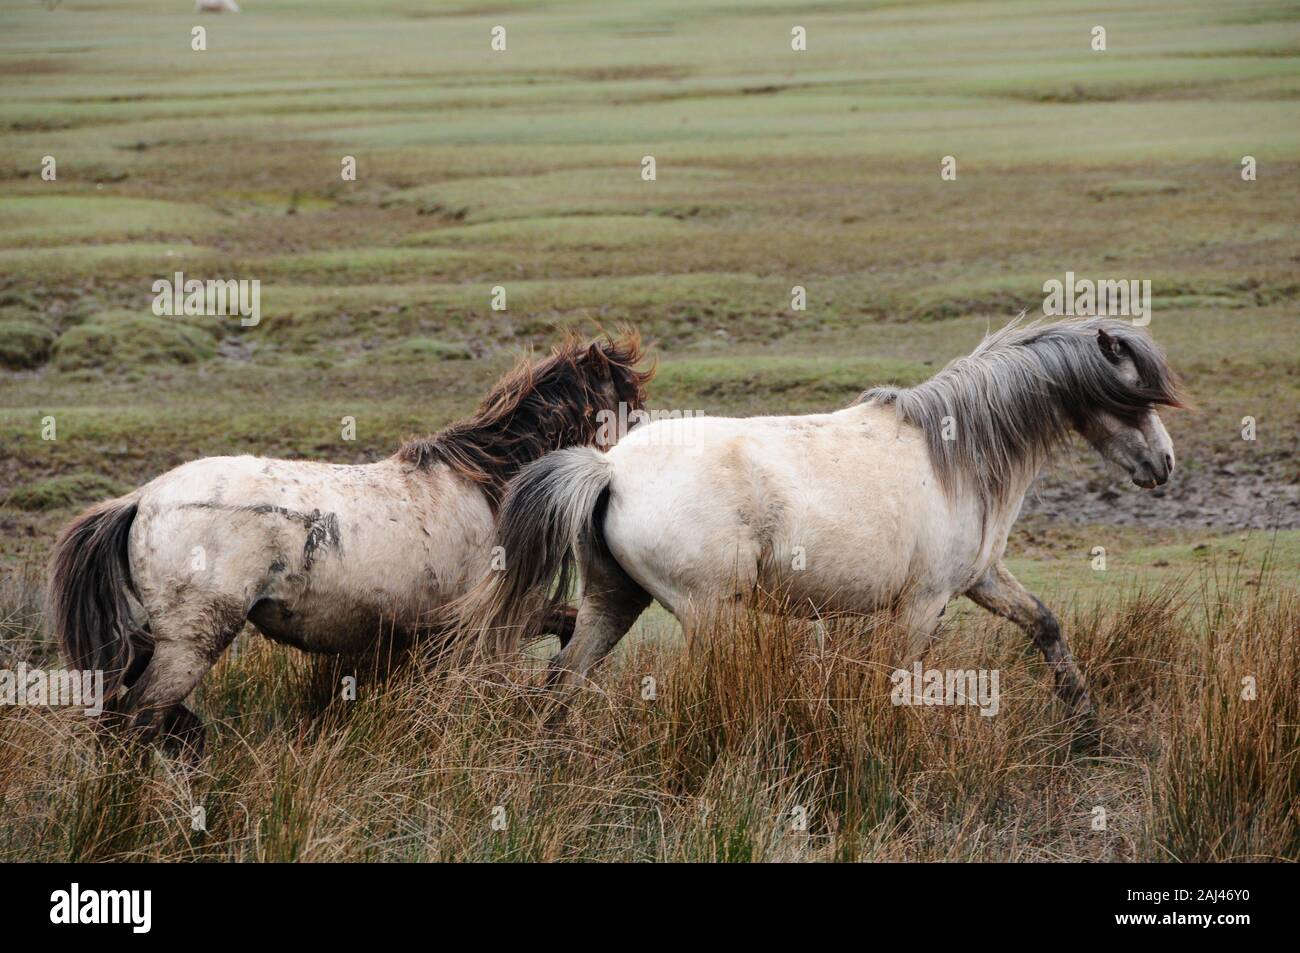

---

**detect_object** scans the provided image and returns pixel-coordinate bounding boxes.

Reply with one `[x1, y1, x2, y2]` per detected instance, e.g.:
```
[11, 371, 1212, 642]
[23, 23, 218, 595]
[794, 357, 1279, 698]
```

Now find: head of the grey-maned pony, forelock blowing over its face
[1074, 320, 1184, 490]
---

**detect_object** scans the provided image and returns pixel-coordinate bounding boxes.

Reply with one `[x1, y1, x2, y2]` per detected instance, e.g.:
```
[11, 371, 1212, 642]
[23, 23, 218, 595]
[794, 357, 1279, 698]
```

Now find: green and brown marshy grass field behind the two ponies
[0, 0, 1300, 857]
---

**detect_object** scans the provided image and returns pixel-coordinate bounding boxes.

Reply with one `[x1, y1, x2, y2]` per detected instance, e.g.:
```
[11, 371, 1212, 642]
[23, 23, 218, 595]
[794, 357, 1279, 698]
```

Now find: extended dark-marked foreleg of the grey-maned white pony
[966, 563, 1100, 746]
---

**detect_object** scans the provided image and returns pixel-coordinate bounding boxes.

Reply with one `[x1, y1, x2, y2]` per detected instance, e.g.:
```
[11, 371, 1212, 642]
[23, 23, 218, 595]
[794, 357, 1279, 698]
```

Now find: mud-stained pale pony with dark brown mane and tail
[48, 332, 654, 754]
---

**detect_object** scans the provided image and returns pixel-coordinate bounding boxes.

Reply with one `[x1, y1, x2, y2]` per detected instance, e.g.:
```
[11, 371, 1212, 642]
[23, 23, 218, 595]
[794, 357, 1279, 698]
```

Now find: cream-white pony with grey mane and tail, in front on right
[462, 319, 1182, 732]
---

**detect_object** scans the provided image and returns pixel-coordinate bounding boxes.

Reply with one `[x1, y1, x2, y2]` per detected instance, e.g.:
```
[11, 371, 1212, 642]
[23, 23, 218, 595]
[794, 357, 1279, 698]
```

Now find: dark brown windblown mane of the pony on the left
[398, 330, 654, 512]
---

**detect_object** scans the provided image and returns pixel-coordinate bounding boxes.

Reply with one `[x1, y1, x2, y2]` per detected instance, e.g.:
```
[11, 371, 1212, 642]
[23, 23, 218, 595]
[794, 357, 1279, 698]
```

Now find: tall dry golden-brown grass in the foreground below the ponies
[0, 564, 1300, 861]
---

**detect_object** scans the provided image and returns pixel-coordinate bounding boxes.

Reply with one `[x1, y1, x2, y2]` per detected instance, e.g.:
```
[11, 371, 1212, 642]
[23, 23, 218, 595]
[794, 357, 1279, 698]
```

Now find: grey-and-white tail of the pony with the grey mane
[455, 447, 614, 660]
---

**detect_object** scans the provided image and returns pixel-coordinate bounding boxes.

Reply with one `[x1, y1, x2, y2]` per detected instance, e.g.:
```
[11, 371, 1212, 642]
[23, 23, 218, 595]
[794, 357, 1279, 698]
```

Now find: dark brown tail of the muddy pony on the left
[47, 493, 153, 701]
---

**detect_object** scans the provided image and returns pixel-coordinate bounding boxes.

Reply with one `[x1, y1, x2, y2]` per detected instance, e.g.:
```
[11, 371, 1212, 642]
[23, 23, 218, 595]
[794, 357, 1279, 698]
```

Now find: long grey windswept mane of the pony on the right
[855, 317, 1182, 507]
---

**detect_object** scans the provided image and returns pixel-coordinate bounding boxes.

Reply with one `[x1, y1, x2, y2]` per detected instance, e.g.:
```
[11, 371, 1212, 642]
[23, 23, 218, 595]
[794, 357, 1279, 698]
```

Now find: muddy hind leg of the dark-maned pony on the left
[117, 599, 244, 761]
